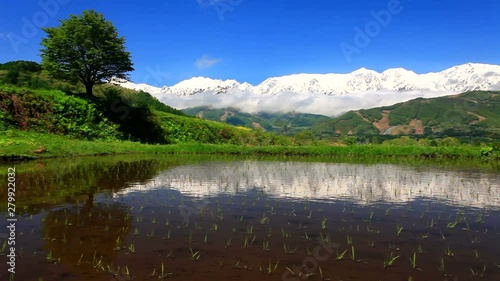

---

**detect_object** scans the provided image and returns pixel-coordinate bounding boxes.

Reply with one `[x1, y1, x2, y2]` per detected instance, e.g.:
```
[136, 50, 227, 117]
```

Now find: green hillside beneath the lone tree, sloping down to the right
[0, 61, 290, 145]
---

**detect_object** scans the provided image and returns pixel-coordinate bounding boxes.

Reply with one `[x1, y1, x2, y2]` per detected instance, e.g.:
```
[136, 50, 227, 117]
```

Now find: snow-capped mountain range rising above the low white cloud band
[109, 63, 500, 98]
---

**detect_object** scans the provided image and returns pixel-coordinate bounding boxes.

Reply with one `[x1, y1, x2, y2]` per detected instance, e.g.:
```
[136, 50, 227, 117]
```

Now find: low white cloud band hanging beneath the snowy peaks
[157, 91, 453, 116]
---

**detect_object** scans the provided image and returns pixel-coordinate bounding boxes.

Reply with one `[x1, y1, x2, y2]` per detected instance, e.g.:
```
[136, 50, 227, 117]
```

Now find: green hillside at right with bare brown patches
[312, 91, 500, 138]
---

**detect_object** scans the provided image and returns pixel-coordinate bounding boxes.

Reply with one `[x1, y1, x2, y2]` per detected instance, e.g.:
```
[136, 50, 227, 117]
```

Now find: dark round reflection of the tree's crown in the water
[42, 194, 132, 266]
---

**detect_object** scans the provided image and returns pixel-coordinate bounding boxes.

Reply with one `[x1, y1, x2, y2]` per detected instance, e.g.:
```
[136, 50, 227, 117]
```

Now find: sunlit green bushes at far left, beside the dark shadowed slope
[0, 86, 119, 139]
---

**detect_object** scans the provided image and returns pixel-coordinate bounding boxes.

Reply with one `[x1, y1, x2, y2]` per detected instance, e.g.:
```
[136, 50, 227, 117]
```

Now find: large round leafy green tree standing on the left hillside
[40, 10, 134, 95]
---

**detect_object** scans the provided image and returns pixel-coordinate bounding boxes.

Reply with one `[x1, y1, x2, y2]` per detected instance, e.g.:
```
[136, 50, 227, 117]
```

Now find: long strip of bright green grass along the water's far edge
[0, 130, 500, 160]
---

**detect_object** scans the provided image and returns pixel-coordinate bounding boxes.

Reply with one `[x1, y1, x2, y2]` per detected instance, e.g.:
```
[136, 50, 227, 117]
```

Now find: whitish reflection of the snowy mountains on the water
[115, 161, 500, 207]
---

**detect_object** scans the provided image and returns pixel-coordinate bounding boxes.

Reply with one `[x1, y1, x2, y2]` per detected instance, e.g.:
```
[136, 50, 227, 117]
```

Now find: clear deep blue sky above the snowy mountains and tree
[0, 0, 500, 86]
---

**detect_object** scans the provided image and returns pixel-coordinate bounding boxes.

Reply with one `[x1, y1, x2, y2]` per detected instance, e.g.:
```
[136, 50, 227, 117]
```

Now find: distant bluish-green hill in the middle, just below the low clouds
[182, 106, 330, 135]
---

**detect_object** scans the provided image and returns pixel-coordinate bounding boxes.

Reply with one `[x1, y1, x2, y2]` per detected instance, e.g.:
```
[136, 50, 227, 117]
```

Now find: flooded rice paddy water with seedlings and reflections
[0, 158, 500, 281]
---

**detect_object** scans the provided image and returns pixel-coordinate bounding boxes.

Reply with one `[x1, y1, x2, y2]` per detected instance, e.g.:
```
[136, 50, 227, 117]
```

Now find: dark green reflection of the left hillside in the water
[0, 160, 169, 213]
